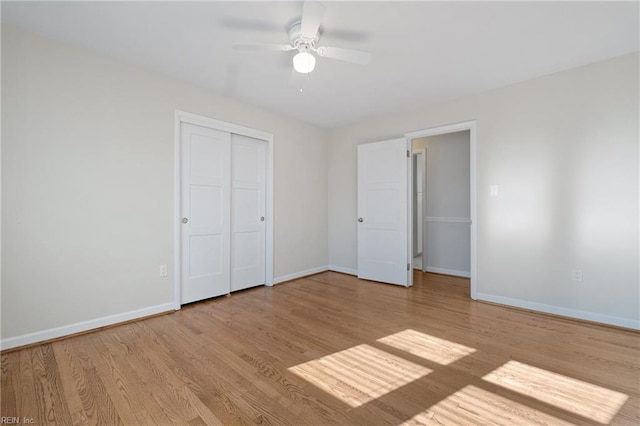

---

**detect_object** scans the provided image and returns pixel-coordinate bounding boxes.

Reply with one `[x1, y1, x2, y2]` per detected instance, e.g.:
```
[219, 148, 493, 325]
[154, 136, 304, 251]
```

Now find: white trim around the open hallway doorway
[405, 120, 478, 300]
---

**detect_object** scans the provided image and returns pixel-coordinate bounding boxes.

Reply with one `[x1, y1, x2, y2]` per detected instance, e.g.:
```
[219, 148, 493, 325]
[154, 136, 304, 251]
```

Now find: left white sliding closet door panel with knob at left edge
[181, 123, 231, 303]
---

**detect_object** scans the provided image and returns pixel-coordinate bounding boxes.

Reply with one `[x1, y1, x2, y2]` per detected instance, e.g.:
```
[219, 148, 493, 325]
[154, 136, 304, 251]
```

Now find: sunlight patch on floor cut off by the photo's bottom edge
[402, 385, 572, 426]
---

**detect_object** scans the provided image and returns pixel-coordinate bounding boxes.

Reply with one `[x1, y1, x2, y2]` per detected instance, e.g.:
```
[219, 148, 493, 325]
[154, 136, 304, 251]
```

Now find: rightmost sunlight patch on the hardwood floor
[483, 361, 629, 423]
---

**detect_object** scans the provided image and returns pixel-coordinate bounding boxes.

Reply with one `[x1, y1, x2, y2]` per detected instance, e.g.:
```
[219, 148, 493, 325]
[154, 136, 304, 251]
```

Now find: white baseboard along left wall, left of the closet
[0, 302, 175, 350]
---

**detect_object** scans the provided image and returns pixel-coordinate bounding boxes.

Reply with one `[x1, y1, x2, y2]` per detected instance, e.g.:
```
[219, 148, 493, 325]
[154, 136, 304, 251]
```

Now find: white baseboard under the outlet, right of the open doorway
[478, 293, 640, 330]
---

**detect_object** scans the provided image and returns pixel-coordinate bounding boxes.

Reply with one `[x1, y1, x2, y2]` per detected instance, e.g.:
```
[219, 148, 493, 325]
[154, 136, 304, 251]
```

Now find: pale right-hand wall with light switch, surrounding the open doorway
[328, 53, 640, 328]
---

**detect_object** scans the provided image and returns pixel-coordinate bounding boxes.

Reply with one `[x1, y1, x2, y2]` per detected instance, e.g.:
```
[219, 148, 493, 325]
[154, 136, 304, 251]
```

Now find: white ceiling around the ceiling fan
[1, 1, 639, 127]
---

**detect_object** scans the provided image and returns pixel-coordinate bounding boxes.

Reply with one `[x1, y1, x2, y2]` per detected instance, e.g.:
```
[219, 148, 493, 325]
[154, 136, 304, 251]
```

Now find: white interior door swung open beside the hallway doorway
[358, 139, 411, 286]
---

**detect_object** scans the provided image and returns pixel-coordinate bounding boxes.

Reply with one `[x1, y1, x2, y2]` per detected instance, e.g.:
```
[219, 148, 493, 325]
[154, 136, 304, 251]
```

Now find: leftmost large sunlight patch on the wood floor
[289, 345, 431, 407]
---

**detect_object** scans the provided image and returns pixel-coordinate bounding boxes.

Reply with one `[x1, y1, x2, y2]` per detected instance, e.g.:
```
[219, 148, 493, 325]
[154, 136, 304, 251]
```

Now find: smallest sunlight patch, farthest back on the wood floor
[378, 329, 476, 365]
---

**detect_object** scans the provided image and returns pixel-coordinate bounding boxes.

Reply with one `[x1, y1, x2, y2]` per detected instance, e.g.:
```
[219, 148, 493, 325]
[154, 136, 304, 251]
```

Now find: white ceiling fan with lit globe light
[233, 1, 372, 74]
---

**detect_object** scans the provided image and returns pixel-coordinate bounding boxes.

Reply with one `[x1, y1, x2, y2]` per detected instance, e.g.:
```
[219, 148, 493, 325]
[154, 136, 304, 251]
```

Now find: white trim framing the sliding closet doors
[173, 110, 273, 310]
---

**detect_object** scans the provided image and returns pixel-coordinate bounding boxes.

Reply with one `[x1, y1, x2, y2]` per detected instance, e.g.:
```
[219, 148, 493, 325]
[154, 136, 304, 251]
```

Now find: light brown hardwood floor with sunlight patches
[0, 272, 640, 425]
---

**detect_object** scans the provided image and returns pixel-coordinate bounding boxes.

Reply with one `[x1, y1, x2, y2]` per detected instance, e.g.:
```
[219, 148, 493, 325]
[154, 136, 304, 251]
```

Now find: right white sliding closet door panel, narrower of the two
[231, 134, 267, 291]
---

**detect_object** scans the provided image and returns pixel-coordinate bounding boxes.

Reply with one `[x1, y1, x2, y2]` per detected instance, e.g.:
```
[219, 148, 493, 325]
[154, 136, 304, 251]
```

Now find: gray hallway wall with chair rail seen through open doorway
[413, 131, 471, 277]
